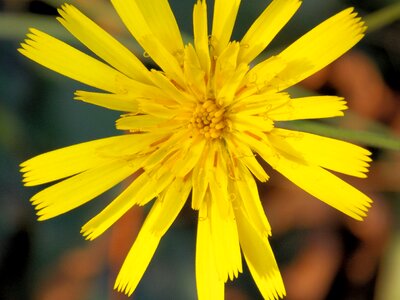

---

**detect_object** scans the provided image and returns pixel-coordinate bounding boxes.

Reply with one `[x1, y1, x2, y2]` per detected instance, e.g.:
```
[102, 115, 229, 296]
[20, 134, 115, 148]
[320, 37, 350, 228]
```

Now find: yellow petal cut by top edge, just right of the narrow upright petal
[211, 0, 240, 56]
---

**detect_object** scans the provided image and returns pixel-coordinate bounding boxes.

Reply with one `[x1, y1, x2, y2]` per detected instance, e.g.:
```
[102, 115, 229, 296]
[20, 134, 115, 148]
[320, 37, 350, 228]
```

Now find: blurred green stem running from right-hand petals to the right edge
[284, 121, 400, 151]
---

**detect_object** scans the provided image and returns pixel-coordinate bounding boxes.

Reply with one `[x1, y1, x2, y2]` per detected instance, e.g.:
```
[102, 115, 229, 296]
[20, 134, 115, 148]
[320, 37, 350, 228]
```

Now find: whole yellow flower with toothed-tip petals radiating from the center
[19, 0, 371, 299]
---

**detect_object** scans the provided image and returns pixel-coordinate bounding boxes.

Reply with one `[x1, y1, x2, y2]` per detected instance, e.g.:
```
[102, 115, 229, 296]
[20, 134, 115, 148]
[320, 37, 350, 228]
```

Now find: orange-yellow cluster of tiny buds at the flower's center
[189, 100, 226, 139]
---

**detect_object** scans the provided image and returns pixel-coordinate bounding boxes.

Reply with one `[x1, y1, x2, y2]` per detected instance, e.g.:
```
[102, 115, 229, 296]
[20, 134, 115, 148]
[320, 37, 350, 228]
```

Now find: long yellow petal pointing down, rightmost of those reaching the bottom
[235, 206, 286, 300]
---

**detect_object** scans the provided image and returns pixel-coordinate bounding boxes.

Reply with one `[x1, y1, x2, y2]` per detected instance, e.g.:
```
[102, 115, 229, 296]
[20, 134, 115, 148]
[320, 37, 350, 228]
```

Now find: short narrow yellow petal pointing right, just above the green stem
[266, 96, 347, 121]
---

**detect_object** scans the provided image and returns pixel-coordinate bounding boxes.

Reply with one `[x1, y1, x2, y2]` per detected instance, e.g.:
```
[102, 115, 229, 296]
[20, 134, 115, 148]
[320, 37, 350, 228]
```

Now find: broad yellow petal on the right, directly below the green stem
[269, 128, 371, 178]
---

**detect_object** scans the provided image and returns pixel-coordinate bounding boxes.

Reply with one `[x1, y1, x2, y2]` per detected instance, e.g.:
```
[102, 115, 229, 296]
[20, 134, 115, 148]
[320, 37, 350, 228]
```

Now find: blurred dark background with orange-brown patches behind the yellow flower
[0, 0, 400, 300]
